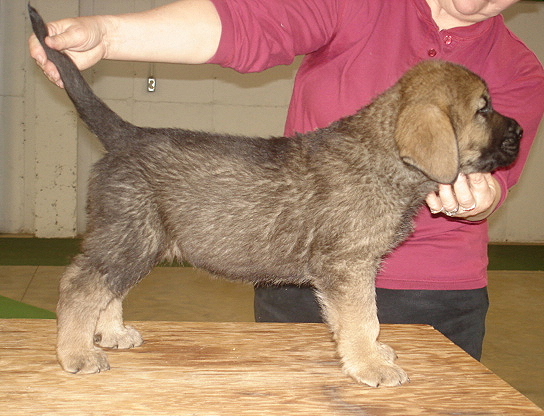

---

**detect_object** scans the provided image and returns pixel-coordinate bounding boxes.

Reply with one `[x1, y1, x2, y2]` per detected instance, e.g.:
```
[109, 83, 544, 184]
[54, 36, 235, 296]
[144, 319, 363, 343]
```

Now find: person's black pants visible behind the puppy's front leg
[255, 285, 489, 360]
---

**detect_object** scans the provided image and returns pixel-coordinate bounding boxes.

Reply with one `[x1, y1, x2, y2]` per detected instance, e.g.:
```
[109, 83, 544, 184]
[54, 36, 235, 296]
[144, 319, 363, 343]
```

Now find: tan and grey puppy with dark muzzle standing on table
[31, 5, 522, 386]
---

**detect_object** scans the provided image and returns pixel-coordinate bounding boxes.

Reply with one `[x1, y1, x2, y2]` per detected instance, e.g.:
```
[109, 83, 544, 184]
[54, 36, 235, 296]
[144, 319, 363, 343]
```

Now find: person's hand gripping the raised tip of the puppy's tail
[28, 16, 107, 87]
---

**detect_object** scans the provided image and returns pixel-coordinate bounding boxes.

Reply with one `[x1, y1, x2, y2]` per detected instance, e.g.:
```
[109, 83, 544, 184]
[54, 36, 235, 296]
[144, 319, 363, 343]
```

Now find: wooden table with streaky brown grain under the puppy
[0, 320, 544, 416]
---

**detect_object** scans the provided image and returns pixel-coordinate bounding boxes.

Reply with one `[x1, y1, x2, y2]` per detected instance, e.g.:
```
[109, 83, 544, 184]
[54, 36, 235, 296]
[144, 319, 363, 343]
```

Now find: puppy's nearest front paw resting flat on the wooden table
[344, 354, 410, 387]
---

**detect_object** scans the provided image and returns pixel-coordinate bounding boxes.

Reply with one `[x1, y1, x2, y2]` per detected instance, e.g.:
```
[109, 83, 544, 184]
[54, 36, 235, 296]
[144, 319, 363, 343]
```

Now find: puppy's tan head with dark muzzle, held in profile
[395, 61, 522, 183]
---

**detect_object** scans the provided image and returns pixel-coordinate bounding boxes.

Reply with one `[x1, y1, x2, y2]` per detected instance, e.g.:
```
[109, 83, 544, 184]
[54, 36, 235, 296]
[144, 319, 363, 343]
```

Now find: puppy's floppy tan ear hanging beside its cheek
[395, 104, 459, 183]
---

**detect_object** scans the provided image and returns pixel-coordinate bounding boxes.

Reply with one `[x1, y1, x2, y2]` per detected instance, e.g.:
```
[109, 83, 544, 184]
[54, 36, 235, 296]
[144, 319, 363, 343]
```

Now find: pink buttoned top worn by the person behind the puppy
[210, 0, 544, 290]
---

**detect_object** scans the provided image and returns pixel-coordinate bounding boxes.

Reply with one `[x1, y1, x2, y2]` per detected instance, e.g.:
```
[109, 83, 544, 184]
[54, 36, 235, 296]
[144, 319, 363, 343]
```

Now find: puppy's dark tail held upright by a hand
[28, 4, 138, 151]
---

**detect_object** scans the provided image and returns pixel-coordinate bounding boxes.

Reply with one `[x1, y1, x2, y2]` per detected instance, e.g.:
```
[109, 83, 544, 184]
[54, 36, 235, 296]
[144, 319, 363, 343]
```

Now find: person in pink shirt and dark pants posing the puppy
[29, 0, 544, 359]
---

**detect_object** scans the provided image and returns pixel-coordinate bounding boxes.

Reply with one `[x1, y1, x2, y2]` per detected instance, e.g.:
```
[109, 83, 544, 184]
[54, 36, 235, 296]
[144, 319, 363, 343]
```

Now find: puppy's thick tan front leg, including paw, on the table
[318, 267, 408, 387]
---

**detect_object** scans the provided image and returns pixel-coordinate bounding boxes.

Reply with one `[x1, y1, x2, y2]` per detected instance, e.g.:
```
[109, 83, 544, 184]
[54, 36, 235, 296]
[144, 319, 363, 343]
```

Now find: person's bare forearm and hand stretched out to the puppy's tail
[29, 0, 221, 86]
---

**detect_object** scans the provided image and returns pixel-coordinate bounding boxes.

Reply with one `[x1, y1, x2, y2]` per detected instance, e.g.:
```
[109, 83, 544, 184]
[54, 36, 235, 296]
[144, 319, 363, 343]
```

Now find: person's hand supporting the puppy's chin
[426, 173, 501, 221]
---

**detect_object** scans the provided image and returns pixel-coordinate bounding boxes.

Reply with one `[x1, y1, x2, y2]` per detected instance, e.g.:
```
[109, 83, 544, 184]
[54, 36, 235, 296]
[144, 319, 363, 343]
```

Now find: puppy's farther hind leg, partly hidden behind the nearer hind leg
[94, 297, 144, 349]
